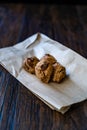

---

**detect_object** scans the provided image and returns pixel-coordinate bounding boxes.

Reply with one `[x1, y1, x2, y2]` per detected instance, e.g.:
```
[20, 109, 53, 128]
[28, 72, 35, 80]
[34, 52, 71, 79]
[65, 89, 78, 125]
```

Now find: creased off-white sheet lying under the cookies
[0, 33, 87, 114]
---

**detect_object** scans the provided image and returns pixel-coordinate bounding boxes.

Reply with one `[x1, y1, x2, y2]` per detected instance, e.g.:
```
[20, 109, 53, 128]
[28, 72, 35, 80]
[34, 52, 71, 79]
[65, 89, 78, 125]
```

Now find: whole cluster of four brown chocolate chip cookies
[23, 54, 66, 83]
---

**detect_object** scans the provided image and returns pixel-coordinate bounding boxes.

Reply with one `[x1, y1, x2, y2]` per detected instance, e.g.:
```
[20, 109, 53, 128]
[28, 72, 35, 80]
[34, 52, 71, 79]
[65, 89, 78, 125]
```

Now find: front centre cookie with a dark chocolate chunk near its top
[35, 60, 53, 83]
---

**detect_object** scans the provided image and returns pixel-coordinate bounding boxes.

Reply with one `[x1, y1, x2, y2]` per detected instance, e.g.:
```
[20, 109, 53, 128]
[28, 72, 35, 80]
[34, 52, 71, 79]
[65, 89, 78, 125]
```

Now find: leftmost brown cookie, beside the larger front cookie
[23, 56, 39, 74]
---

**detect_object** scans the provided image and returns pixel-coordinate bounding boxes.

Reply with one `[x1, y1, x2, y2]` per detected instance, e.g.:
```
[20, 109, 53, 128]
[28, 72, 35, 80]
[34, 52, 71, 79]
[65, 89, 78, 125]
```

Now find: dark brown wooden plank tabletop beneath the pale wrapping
[0, 4, 87, 130]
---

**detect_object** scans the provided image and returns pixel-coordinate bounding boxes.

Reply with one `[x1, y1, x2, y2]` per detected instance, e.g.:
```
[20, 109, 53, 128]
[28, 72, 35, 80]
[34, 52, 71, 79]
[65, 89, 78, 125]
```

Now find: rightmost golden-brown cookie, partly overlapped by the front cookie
[52, 62, 66, 83]
